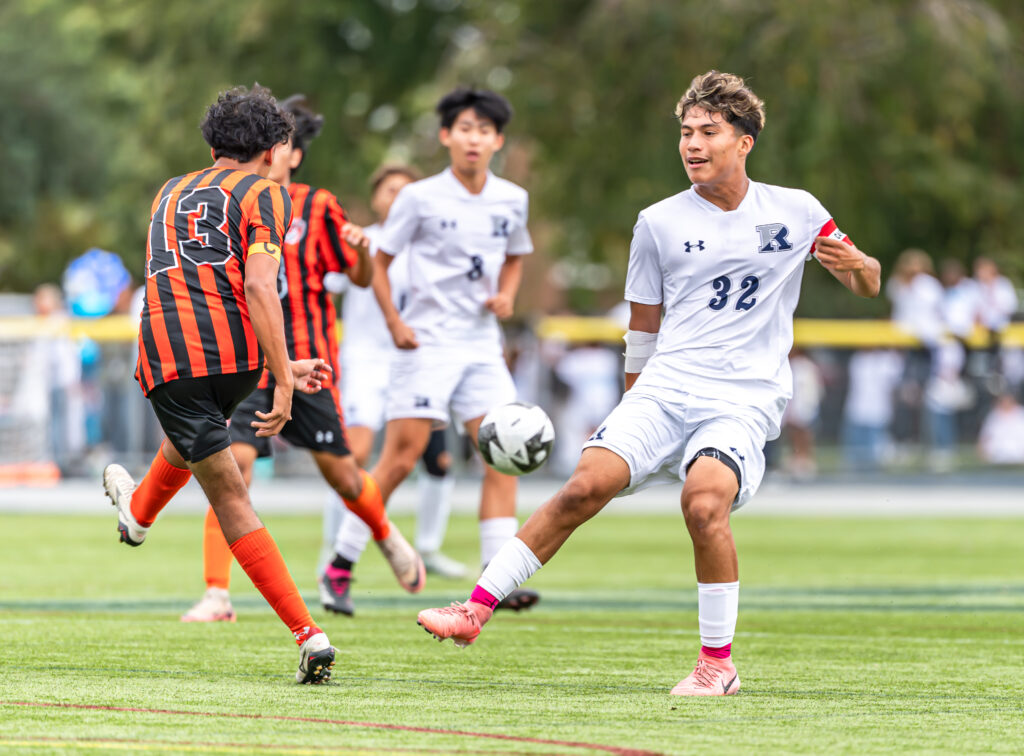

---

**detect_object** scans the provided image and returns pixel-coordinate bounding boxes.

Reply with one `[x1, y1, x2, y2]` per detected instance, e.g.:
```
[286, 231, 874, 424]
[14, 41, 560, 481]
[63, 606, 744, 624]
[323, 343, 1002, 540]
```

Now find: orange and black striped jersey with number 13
[135, 167, 292, 394]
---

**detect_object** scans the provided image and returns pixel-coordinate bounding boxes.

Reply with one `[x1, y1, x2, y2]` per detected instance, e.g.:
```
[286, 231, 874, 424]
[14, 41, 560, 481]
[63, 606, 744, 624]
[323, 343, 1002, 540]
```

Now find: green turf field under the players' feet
[0, 505, 1024, 754]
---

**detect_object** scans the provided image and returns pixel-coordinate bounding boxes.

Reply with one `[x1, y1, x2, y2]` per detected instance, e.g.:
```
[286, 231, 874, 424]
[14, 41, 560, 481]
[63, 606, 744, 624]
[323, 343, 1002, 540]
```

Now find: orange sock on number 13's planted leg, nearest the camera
[231, 528, 321, 645]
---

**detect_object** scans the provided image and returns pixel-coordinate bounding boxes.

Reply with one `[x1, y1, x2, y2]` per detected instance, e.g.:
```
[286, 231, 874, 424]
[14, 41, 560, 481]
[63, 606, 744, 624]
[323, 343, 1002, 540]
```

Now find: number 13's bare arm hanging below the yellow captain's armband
[245, 249, 295, 436]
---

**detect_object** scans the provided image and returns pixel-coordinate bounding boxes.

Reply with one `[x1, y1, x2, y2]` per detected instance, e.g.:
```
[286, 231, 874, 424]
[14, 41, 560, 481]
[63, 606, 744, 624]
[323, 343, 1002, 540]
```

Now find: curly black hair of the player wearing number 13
[200, 84, 295, 163]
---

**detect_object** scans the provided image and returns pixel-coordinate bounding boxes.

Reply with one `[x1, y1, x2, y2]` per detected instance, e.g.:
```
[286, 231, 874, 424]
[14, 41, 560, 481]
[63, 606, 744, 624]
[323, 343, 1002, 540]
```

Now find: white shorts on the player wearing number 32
[583, 389, 768, 511]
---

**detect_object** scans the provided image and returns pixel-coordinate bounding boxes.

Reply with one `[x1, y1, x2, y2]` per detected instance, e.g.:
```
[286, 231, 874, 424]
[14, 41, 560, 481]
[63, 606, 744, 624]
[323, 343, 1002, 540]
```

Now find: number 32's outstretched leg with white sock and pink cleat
[417, 448, 630, 646]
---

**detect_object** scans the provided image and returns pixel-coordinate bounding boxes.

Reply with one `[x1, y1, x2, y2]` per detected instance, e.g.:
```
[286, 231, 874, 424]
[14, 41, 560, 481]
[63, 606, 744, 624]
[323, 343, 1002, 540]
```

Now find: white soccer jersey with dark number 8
[380, 168, 534, 348]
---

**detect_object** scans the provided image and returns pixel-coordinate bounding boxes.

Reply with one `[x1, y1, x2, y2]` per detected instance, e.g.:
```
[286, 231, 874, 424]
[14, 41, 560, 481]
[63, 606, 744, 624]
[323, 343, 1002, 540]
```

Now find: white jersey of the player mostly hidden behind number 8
[341, 223, 409, 365]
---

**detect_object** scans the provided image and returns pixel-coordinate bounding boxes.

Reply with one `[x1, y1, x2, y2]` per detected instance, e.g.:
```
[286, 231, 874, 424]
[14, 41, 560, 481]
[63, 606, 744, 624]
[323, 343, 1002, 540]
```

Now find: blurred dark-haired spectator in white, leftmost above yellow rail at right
[886, 249, 945, 456]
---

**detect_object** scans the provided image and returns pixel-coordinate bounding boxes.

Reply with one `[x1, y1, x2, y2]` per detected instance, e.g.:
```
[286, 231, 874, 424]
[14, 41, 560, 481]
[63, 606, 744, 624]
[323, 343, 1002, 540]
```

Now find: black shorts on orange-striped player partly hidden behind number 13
[228, 382, 351, 457]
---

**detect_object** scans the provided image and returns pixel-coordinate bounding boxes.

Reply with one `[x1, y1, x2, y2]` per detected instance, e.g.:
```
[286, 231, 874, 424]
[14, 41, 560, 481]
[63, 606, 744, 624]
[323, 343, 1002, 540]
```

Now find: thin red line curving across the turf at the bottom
[0, 701, 659, 756]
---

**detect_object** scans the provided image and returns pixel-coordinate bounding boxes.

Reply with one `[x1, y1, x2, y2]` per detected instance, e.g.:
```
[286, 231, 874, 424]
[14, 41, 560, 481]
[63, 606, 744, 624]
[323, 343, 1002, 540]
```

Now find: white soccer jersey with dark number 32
[626, 181, 846, 437]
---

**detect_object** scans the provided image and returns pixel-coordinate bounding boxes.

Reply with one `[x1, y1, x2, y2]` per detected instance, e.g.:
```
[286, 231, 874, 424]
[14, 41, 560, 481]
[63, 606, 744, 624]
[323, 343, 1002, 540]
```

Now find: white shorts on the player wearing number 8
[387, 344, 516, 427]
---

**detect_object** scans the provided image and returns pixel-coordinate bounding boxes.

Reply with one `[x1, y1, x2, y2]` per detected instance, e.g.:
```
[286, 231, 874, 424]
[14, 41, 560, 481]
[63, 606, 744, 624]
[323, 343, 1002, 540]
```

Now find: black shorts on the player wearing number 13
[148, 369, 263, 462]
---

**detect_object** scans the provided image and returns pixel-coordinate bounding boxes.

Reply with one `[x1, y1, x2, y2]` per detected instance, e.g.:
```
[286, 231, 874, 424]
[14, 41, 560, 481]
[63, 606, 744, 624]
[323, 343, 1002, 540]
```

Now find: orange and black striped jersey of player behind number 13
[260, 183, 356, 388]
